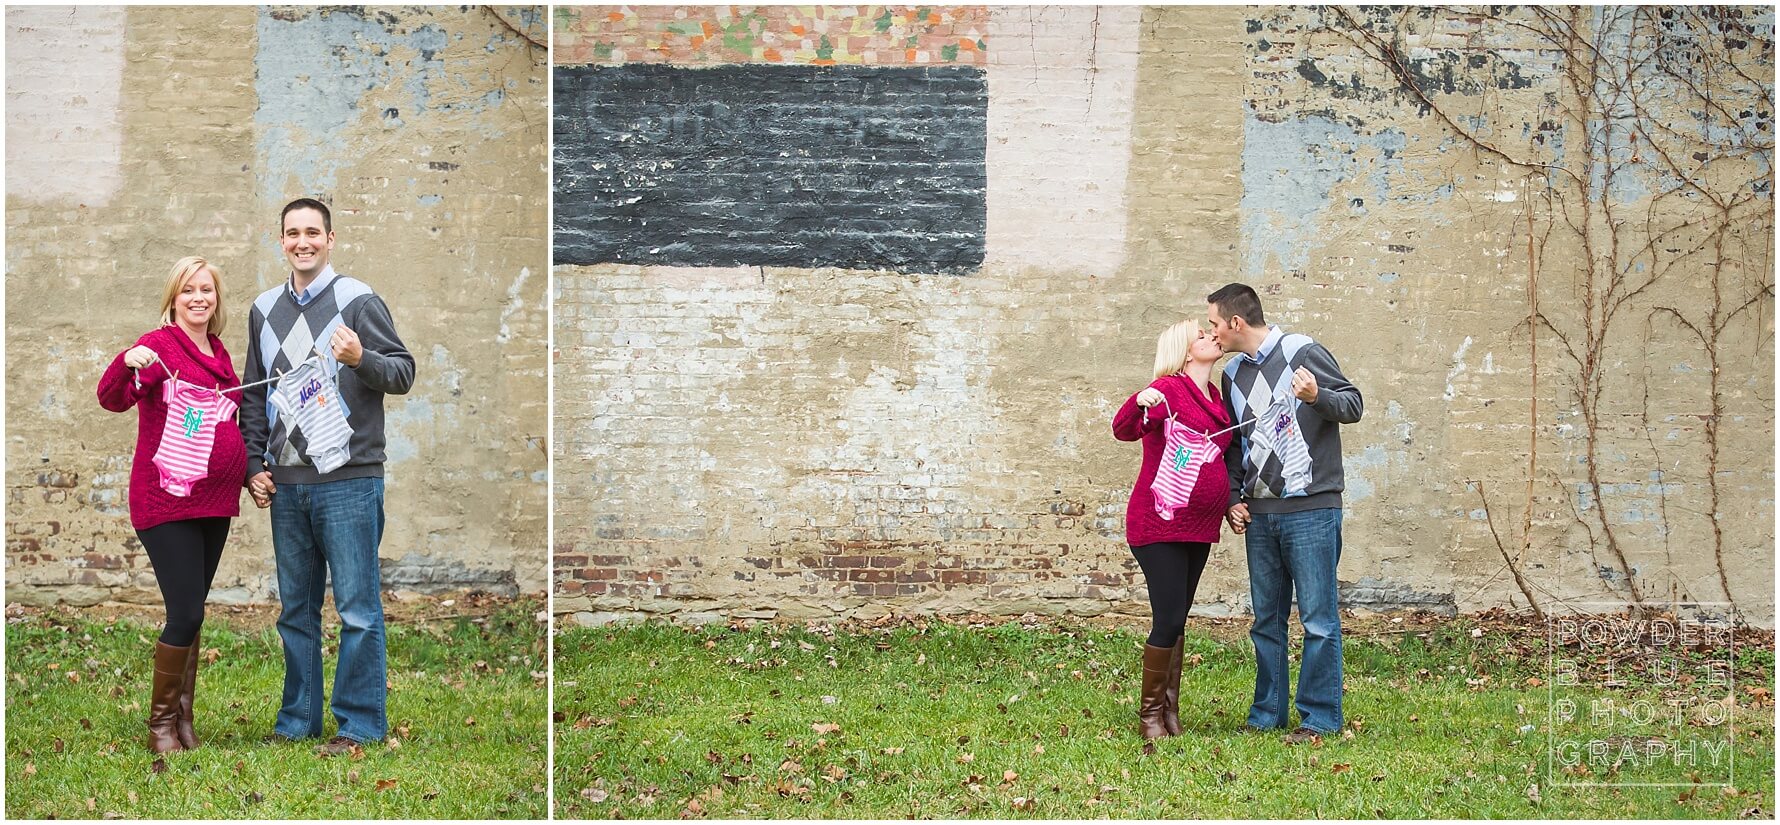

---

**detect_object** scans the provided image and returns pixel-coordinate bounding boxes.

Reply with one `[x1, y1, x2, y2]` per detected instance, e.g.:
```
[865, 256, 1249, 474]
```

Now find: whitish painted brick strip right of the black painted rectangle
[984, 5, 1143, 274]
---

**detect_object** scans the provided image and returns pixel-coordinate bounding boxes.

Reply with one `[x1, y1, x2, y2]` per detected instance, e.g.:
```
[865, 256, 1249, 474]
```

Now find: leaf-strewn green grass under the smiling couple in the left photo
[5, 599, 546, 820]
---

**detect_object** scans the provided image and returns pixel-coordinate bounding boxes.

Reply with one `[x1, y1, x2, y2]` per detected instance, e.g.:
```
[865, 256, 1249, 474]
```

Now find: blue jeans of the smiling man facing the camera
[272, 478, 388, 741]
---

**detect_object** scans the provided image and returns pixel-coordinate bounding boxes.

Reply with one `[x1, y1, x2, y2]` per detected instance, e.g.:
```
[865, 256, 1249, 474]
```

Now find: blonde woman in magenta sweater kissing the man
[1113, 321, 1230, 739]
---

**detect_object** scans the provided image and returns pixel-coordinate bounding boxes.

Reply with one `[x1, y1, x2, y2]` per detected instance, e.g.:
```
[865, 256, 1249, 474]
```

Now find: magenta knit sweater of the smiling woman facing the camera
[100, 326, 247, 529]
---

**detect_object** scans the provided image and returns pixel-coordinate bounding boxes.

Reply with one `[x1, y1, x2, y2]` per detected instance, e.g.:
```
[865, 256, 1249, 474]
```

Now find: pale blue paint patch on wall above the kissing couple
[1242, 107, 1408, 276]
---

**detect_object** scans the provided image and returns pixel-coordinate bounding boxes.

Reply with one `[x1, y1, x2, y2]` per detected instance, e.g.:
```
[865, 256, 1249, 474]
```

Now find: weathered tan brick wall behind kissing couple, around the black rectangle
[555, 7, 1775, 625]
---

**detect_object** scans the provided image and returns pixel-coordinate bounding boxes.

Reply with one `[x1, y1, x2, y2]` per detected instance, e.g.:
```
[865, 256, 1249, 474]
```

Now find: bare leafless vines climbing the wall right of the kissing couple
[1321, 7, 1775, 613]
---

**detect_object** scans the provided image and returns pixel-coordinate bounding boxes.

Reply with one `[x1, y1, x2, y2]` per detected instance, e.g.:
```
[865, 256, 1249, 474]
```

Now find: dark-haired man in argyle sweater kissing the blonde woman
[1205, 283, 1363, 745]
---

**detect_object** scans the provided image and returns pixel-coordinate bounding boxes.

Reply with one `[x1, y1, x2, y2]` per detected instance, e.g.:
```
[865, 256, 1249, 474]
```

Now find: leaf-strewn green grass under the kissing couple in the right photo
[554, 618, 1775, 818]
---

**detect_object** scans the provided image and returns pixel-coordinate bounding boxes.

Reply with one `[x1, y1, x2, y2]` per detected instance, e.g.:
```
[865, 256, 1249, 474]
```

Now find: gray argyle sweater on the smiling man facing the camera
[240, 267, 415, 485]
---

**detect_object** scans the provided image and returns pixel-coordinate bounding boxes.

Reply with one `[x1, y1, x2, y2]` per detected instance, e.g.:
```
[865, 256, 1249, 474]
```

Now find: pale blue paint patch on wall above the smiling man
[253, 9, 447, 203]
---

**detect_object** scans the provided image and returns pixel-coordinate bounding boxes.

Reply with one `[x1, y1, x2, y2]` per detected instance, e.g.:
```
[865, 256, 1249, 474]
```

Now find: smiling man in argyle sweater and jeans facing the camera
[240, 198, 415, 756]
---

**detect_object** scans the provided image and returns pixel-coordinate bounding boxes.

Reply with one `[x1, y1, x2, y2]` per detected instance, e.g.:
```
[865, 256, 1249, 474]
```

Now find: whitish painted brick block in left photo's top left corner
[5, 5, 125, 207]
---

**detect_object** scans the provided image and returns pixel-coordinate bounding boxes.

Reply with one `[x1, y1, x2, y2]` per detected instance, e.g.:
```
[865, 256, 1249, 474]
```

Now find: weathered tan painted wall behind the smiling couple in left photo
[5, 7, 548, 604]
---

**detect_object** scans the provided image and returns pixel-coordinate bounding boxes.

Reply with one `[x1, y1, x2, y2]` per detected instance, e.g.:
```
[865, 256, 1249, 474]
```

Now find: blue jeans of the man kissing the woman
[1244, 508, 1342, 732]
